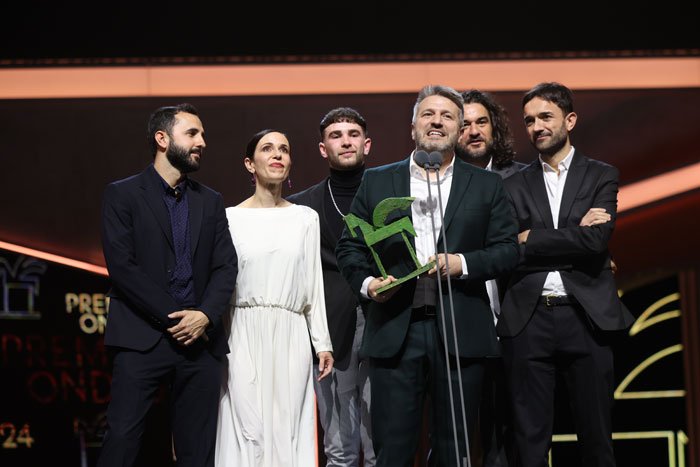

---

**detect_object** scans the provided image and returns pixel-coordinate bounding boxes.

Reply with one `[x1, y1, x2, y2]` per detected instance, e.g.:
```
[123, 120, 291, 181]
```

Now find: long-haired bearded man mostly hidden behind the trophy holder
[455, 89, 525, 467]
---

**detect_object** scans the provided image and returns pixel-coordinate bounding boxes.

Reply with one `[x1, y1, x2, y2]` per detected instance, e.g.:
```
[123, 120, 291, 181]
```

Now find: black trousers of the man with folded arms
[501, 304, 615, 467]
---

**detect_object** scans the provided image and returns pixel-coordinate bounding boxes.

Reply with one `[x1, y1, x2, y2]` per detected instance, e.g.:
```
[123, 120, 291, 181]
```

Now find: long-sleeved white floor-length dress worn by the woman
[216, 205, 332, 467]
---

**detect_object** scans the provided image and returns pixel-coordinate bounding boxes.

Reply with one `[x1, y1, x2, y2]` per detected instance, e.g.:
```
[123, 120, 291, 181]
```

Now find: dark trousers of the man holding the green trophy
[369, 319, 484, 467]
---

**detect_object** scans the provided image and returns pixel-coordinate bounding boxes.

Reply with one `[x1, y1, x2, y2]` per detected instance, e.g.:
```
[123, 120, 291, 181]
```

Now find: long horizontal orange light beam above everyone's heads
[0, 57, 700, 99]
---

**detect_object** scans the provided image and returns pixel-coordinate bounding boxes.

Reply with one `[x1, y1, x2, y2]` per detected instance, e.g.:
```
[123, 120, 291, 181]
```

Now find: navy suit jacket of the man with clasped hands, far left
[102, 165, 238, 356]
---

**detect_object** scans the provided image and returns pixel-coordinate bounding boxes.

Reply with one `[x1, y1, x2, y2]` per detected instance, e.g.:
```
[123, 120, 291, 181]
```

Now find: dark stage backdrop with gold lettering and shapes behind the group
[0, 88, 700, 467]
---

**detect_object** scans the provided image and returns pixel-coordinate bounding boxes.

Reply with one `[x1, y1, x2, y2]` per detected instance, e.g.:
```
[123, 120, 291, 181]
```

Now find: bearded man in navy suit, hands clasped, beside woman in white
[98, 104, 238, 467]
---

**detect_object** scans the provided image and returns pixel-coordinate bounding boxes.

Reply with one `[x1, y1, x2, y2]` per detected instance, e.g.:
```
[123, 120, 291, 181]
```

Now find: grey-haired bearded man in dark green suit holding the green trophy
[336, 85, 518, 467]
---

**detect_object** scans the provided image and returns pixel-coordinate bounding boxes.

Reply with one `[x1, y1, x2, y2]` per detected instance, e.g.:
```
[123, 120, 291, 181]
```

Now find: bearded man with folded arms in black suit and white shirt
[498, 83, 633, 467]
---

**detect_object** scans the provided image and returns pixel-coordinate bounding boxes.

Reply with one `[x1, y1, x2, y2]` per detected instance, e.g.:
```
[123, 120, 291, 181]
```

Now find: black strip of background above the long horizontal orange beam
[0, 0, 700, 65]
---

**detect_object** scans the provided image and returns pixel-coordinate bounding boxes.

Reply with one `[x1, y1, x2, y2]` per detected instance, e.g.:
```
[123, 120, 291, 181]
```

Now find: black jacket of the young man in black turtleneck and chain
[287, 178, 358, 370]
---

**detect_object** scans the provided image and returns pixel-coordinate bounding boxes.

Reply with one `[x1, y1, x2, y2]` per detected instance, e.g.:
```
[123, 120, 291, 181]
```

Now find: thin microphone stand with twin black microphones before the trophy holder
[415, 151, 471, 467]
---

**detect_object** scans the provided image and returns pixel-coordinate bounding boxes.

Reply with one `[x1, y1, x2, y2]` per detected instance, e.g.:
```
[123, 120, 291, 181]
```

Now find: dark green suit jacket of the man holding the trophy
[336, 158, 518, 358]
